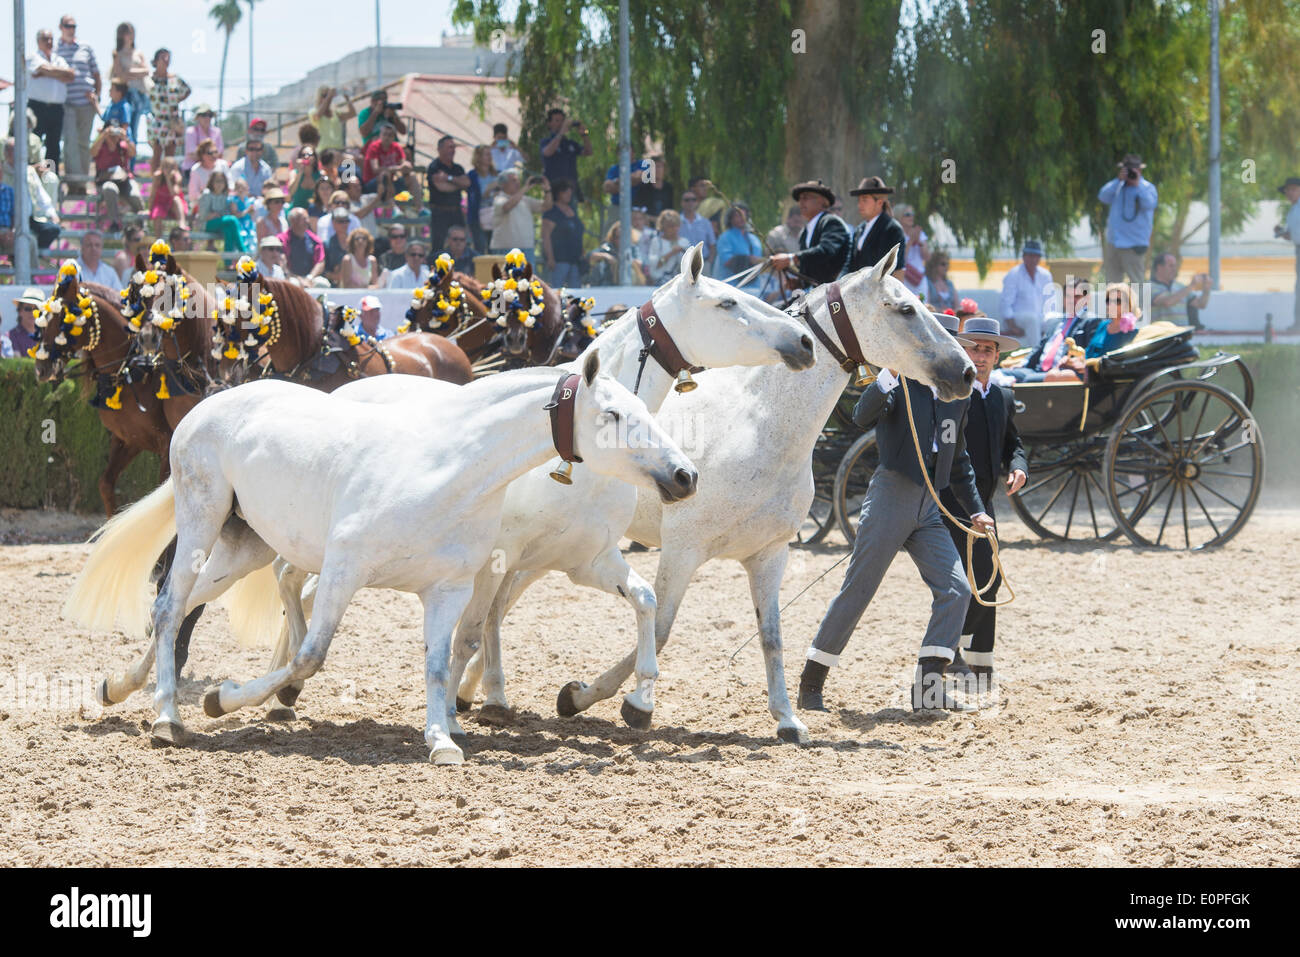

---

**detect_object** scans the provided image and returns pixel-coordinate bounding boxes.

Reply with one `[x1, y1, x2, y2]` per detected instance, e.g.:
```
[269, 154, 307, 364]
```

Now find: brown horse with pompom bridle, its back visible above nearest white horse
[218, 276, 473, 384]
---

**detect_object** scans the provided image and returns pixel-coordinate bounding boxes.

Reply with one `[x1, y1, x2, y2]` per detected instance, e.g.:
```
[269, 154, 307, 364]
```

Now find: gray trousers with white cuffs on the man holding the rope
[807, 468, 971, 667]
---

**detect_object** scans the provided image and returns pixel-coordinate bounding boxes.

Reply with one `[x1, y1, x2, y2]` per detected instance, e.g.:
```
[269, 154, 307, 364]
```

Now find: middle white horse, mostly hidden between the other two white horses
[248, 244, 814, 737]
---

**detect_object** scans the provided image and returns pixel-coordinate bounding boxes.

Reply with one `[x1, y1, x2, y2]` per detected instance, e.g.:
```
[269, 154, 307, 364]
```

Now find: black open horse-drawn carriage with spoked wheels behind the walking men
[800, 328, 1264, 549]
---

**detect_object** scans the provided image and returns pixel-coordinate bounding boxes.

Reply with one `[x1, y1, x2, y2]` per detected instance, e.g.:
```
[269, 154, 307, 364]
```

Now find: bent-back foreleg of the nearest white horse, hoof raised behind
[203, 545, 365, 718]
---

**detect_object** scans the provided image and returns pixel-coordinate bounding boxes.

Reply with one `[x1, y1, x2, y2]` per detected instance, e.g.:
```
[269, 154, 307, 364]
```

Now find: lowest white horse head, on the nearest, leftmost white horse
[573, 351, 699, 503]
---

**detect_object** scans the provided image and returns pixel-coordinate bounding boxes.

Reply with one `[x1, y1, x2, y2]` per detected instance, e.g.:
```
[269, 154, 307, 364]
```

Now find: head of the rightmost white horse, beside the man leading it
[837, 246, 975, 402]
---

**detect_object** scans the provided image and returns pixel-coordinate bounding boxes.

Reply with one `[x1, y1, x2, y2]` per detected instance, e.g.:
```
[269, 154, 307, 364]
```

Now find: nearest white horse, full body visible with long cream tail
[65, 355, 698, 765]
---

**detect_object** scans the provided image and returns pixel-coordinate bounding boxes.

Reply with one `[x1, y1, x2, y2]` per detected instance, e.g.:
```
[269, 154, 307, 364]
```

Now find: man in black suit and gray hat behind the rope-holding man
[939, 316, 1030, 690]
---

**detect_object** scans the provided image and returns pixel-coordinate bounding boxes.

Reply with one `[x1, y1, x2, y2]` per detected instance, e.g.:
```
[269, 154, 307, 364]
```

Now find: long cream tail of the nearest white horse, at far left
[64, 479, 176, 635]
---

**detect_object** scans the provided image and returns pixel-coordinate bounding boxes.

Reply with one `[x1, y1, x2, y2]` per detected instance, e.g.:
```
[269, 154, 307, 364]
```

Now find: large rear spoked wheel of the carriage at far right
[1106, 380, 1264, 549]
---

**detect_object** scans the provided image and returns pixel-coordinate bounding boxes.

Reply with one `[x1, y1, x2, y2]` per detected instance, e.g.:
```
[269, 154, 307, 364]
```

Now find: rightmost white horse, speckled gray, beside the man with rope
[458, 250, 975, 744]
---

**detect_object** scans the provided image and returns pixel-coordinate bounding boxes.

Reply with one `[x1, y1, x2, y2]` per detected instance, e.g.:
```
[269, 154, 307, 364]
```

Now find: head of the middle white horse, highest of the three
[646, 243, 816, 369]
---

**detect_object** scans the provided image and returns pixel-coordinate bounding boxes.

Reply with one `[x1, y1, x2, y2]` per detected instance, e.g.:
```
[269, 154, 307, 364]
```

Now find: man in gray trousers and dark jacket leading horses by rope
[798, 325, 993, 711]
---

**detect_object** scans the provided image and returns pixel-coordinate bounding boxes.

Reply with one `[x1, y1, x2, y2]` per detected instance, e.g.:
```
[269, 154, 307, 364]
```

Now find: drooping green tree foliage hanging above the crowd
[455, 0, 1300, 268]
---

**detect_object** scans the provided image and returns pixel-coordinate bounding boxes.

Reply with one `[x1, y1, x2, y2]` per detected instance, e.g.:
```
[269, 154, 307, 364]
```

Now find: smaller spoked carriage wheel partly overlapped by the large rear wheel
[1011, 439, 1119, 541]
